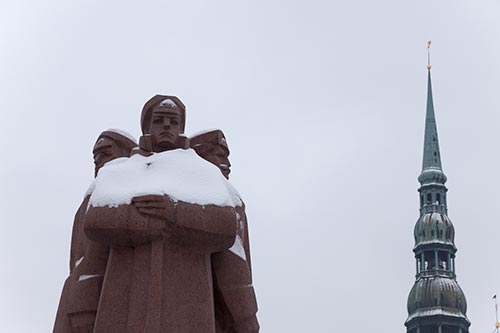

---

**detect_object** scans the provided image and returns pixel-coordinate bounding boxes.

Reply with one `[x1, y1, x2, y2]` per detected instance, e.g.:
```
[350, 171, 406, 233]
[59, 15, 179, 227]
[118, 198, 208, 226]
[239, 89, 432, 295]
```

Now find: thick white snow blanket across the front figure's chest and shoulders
[90, 149, 241, 207]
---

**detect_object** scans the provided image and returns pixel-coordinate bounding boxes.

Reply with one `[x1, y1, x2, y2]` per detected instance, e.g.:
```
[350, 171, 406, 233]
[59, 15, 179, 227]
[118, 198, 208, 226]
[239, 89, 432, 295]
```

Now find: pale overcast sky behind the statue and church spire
[0, 0, 500, 333]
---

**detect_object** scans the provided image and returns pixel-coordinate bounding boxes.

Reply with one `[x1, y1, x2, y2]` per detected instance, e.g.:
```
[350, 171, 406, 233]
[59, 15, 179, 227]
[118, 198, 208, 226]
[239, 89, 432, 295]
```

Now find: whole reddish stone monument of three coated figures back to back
[54, 95, 259, 333]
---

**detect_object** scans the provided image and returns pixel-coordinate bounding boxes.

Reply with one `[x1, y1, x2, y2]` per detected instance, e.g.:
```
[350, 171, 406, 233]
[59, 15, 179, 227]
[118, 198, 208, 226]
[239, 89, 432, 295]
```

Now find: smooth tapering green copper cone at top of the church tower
[422, 68, 442, 171]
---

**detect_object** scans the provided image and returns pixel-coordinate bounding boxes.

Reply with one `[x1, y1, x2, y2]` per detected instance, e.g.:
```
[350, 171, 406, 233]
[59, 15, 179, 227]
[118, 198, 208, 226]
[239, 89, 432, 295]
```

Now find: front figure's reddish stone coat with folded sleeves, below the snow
[85, 200, 237, 333]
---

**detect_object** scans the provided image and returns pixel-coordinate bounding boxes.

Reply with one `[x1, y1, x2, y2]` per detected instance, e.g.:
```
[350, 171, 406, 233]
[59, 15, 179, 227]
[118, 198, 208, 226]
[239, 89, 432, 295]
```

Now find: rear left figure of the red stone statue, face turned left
[54, 130, 137, 333]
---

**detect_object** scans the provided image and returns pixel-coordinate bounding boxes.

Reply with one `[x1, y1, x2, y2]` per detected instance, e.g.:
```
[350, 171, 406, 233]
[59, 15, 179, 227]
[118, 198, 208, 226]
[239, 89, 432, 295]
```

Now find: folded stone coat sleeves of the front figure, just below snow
[85, 200, 238, 253]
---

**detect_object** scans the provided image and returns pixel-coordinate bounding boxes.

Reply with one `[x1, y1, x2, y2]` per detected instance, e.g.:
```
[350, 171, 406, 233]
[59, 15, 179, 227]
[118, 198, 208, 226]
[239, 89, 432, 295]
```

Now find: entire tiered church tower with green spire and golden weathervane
[405, 42, 470, 333]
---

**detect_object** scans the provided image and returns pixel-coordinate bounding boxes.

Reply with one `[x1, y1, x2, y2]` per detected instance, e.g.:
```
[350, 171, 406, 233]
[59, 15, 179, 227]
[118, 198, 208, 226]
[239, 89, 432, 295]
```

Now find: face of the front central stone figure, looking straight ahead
[149, 107, 181, 151]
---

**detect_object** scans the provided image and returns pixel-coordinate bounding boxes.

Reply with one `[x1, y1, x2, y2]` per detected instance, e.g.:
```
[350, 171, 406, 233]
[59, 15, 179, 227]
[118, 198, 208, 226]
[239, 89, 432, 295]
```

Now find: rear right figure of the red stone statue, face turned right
[190, 130, 259, 333]
